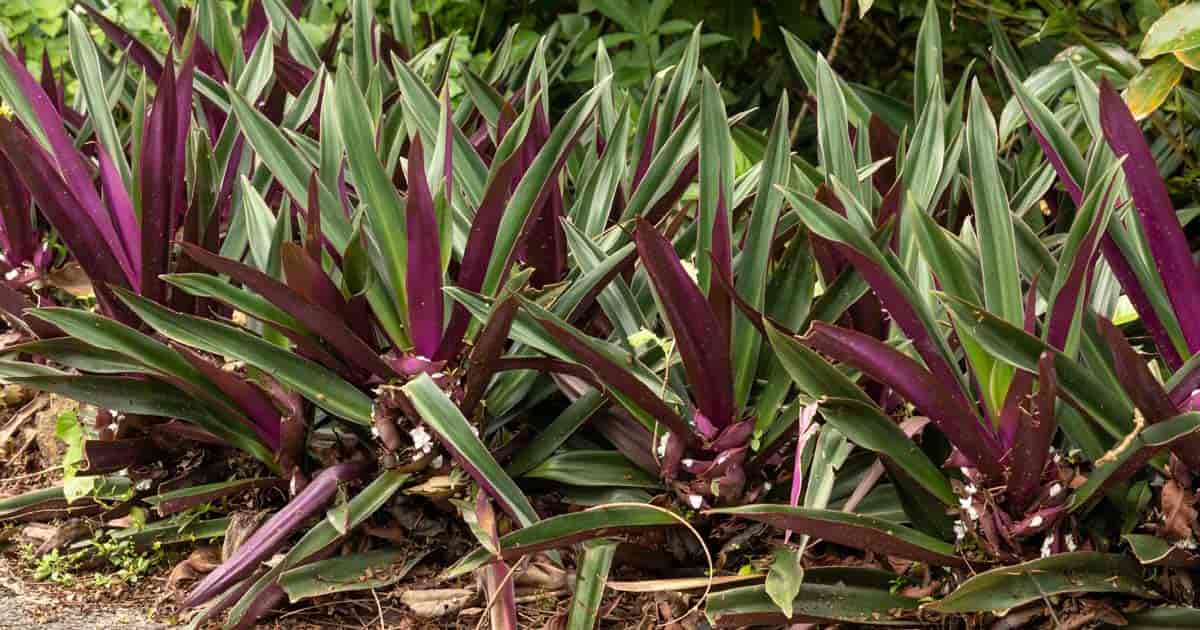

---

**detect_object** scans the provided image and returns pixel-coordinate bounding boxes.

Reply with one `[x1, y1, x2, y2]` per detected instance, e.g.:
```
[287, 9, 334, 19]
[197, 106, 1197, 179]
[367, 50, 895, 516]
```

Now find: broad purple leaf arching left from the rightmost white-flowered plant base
[802, 322, 1003, 479]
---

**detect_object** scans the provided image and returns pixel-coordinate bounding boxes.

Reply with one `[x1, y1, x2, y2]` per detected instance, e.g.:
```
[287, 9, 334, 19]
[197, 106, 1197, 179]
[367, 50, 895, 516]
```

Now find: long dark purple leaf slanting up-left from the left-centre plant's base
[180, 242, 396, 379]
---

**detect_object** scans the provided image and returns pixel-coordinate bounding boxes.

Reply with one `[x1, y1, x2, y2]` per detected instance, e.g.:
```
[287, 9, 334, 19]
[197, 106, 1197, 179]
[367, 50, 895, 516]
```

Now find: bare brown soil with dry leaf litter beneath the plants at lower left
[0, 386, 676, 630]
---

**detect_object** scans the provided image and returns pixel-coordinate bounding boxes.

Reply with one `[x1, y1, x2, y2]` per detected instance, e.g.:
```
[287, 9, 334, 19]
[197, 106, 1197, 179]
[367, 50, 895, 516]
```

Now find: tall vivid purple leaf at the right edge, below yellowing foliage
[1100, 79, 1200, 352]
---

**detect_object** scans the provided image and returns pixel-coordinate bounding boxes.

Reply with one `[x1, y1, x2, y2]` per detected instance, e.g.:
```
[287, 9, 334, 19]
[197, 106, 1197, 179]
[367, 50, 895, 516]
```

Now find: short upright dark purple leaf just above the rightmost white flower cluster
[1006, 352, 1058, 514]
